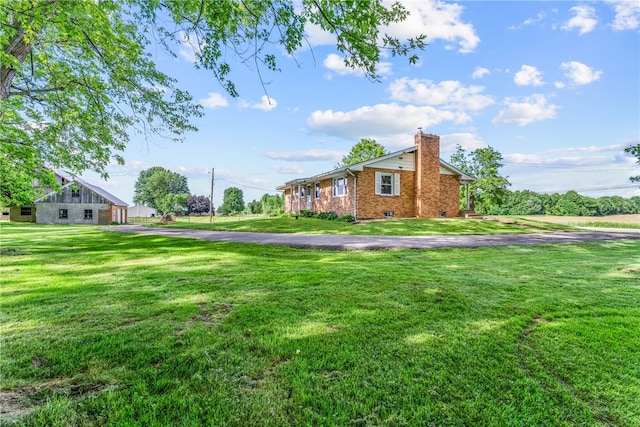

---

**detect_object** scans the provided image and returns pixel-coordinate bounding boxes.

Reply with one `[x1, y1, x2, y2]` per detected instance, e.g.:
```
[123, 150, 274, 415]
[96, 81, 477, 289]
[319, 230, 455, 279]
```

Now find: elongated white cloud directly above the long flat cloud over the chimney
[389, 77, 494, 111]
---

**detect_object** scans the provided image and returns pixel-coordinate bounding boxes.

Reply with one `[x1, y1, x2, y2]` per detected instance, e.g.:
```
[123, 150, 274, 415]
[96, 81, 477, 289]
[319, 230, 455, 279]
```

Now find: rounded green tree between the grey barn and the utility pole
[133, 166, 190, 213]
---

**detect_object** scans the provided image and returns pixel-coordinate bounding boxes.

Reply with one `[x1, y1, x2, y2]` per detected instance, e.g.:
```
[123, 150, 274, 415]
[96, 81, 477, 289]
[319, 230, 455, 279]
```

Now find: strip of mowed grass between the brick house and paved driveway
[148, 215, 578, 236]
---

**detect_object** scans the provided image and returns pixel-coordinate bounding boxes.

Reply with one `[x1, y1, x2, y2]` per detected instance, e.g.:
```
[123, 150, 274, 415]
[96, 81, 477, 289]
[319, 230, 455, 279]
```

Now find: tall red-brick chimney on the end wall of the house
[414, 131, 440, 218]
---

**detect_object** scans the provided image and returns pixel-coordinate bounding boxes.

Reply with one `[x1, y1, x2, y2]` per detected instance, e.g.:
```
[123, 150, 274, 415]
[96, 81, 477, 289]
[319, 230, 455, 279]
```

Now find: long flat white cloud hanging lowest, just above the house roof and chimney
[307, 103, 470, 140]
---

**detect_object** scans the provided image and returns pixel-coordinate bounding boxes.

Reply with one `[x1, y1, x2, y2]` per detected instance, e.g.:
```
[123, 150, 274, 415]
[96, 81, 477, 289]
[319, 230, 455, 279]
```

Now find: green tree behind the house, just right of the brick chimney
[450, 145, 511, 213]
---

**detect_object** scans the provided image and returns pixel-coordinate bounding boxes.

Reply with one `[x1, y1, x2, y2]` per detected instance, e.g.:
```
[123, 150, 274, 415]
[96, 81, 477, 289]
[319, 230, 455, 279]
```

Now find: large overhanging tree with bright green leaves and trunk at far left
[0, 0, 425, 205]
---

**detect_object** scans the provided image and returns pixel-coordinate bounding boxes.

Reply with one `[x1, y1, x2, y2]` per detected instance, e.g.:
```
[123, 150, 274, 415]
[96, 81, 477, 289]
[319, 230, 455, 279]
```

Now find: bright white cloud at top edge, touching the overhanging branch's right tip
[386, 0, 480, 53]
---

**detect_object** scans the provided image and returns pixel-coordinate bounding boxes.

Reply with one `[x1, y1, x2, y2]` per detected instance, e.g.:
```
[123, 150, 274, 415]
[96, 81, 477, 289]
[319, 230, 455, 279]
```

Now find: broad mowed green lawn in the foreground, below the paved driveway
[0, 224, 640, 426]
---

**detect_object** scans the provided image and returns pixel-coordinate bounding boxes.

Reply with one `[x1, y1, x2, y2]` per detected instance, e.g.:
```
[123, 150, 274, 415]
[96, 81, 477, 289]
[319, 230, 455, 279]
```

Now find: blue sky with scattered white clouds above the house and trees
[85, 0, 640, 206]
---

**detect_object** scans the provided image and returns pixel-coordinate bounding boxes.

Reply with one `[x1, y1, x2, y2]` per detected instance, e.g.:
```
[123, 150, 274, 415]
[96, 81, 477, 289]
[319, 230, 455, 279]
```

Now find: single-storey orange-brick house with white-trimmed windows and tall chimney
[277, 132, 476, 219]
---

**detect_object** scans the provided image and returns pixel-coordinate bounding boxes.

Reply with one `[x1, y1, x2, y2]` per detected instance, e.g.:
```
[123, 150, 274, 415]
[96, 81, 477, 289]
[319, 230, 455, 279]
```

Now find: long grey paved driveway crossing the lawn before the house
[104, 225, 640, 250]
